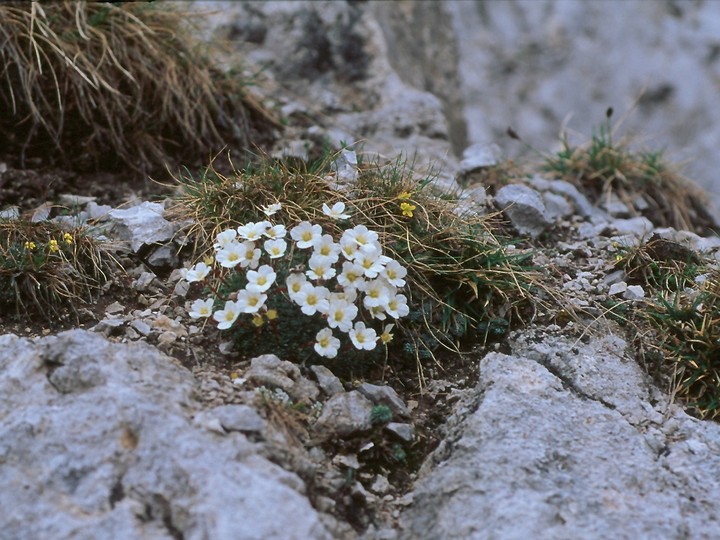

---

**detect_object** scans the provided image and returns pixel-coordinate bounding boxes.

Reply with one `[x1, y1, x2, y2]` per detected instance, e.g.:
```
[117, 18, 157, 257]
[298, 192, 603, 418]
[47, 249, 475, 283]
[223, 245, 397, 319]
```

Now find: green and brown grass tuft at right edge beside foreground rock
[618, 236, 720, 420]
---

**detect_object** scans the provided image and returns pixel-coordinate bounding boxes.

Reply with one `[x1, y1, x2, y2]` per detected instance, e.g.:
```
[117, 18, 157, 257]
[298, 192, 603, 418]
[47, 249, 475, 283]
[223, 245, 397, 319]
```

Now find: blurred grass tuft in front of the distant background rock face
[542, 109, 715, 234]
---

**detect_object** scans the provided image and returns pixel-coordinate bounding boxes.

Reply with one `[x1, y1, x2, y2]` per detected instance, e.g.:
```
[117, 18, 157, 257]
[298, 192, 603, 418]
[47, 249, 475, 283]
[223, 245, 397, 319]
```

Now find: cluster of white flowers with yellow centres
[183, 202, 410, 358]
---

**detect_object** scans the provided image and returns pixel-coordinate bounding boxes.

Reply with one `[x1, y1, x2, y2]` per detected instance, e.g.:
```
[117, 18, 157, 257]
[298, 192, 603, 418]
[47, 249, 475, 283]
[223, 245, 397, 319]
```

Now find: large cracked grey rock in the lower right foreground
[401, 329, 720, 539]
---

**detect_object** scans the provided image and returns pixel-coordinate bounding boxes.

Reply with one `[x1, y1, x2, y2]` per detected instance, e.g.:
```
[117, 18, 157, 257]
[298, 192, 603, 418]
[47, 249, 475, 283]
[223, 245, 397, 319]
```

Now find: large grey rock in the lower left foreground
[0, 330, 329, 540]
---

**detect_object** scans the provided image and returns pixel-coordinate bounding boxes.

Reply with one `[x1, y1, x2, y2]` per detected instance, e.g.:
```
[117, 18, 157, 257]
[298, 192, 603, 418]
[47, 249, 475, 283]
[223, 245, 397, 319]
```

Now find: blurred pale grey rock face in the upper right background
[448, 0, 720, 215]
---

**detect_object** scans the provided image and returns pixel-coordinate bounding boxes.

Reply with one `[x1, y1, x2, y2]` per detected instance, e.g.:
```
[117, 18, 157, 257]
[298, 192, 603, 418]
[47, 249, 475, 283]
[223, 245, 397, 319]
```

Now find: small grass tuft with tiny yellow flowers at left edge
[0, 220, 114, 319]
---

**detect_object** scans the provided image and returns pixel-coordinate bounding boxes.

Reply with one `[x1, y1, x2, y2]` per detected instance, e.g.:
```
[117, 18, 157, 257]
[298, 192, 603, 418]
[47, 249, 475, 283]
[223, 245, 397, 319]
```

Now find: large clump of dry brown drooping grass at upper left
[0, 0, 278, 172]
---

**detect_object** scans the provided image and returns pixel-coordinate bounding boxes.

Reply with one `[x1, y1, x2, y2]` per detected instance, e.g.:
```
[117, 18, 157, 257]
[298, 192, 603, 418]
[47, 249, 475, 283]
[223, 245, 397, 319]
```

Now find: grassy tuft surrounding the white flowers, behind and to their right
[181, 151, 535, 368]
